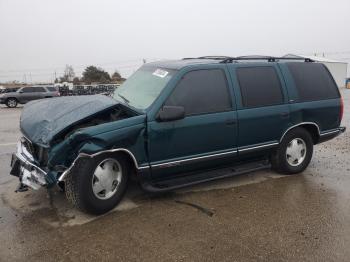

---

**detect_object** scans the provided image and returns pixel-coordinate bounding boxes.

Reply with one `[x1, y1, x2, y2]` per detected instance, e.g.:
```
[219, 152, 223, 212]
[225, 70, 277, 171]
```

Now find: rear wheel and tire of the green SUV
[271, 127, 314, 174]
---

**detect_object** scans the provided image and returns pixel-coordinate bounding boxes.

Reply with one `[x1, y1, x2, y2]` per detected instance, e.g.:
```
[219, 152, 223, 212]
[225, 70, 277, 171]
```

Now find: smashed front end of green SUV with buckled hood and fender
[10, 94, 145, 191]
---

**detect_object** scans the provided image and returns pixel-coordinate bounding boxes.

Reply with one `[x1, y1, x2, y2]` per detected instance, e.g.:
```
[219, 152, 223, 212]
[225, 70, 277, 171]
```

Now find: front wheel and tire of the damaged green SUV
[65, 154, 130, 215]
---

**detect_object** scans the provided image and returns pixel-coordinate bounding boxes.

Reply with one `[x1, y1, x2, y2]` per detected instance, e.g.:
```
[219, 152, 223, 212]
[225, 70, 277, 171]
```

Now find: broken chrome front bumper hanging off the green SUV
[10, 142, 47, 190]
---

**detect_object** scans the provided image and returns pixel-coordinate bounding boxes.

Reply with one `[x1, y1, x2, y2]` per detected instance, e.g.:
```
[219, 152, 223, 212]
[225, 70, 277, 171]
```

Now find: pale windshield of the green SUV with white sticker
[113, 66, 175, 110]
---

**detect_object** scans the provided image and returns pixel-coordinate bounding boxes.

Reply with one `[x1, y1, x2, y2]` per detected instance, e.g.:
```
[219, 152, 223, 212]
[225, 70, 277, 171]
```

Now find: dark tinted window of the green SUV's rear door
[236, 66, 283, 108]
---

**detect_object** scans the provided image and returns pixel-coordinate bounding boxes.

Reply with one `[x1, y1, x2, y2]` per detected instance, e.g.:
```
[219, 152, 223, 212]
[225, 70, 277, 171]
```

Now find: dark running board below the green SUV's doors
[141, 160, 271, 193]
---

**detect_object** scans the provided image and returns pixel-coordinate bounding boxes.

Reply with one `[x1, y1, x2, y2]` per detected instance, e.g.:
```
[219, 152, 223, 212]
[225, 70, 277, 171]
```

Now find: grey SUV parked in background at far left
[0, 86, 60, 107]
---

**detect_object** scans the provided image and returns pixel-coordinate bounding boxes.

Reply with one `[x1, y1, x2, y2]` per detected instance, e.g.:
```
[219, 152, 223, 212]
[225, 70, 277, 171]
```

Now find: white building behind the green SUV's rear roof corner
[285, 54, 348, 87]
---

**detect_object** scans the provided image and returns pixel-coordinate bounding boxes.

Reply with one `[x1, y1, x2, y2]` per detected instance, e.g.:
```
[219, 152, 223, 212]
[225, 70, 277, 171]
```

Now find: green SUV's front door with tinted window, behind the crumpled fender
[148, 68, 237, 179]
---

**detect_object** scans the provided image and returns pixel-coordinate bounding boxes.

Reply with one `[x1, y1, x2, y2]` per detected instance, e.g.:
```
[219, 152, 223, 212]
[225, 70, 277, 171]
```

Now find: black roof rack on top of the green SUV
[184, 55, 315, 63]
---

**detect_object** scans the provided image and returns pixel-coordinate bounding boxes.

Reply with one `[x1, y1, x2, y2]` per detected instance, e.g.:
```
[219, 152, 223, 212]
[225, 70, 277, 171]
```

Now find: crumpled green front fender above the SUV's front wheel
[48, 115, 148, 183]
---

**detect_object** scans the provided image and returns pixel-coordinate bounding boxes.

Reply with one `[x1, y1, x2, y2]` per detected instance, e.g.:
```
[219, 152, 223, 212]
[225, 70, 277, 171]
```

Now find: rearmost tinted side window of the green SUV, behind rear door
[287, 63, 339, 102]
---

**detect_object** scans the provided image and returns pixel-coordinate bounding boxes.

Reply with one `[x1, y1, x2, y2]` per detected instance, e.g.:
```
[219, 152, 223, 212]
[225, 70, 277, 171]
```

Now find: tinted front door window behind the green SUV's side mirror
[165, 69, 232, 115]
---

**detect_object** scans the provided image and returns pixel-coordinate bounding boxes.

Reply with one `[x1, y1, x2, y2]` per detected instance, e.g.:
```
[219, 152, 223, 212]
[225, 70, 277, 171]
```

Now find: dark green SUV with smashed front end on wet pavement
[11, 57, 345, 214]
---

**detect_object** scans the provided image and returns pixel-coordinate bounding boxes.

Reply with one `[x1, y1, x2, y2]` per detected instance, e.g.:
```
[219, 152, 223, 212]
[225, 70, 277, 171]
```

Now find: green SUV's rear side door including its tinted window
[230, 63, 290, 155]
